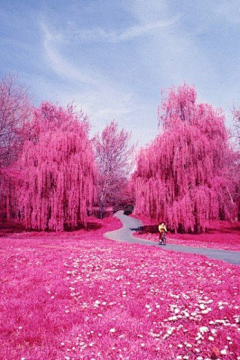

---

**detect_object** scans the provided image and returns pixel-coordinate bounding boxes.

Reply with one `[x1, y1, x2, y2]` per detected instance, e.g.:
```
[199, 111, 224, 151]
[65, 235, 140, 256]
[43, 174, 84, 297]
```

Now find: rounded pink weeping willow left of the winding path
[17, 103, 95, 231]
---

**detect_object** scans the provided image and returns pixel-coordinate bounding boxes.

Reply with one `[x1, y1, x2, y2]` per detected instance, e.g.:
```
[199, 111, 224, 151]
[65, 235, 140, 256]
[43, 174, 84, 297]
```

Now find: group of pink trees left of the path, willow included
[0, 75, 133, 231]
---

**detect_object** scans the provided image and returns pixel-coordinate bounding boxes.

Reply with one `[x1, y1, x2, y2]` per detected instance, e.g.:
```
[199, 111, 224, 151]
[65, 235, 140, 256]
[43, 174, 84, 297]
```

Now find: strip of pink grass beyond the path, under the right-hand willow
[134, 218, 240, 251]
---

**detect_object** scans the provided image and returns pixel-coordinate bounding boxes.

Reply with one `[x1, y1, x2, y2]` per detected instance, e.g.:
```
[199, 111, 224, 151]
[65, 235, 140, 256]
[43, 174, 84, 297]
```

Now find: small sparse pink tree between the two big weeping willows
[93, 121, 134, 216]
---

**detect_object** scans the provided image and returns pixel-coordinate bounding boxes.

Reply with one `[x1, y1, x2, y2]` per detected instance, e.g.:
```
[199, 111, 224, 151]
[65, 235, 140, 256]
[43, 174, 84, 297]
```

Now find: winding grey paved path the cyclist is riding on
[104, 211, 240, 265]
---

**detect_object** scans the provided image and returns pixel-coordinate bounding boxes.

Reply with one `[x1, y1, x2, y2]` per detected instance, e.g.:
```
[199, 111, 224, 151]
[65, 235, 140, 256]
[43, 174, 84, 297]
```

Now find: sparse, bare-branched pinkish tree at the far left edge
[0, 74, 31, 220]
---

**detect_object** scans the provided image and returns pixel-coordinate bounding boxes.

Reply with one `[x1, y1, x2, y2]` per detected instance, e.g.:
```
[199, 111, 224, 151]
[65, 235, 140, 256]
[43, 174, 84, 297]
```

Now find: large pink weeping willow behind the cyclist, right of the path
[133, 84, 235, 232]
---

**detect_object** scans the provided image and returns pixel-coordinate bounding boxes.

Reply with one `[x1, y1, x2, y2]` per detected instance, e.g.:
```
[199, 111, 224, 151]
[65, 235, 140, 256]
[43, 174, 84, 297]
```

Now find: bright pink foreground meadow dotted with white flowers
[0, 218, 240, 360]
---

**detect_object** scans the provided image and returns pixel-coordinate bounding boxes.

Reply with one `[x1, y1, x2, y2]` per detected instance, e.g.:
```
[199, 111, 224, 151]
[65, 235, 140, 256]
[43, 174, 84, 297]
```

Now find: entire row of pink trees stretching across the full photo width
[0, 75, 240, 232]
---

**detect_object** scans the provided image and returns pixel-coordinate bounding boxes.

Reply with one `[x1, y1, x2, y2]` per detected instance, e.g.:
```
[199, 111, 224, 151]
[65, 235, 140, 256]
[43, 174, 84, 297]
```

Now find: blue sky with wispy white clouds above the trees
[0, 0, 240, 146]
